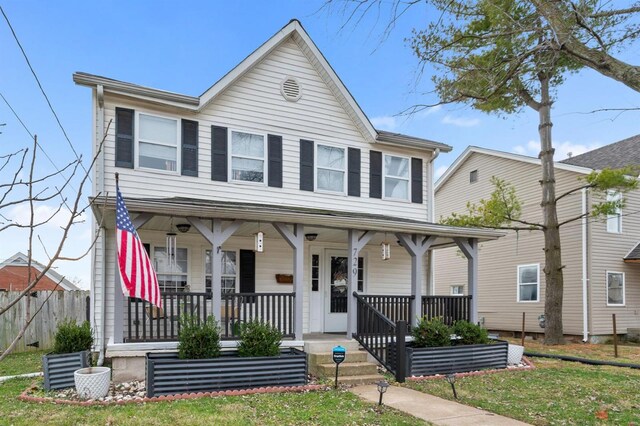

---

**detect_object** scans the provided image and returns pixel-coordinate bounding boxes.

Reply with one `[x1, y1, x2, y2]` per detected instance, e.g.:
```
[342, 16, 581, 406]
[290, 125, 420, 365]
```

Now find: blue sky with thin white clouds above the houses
[0, 0, 640, 287]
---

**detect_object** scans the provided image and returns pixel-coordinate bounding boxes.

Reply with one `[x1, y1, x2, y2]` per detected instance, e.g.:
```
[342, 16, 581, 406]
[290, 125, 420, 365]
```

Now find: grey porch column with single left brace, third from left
[272, 222, 304, 340]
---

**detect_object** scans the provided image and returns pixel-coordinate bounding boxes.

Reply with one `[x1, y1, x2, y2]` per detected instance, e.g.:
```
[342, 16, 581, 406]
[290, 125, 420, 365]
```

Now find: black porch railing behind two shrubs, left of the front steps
[124, 292, 295, 342]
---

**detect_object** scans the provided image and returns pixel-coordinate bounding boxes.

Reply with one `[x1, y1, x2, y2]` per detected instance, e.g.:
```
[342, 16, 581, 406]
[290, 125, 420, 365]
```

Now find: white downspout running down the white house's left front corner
[94, 84, 107, 366]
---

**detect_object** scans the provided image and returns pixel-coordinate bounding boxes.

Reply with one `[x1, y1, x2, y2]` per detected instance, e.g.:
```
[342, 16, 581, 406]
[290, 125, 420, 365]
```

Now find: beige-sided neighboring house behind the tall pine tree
[435, 135, 640, 341]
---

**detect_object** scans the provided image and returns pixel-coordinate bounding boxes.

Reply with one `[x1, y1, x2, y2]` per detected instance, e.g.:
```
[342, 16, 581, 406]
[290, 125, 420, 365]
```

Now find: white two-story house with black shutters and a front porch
[73, 20, 501, 372]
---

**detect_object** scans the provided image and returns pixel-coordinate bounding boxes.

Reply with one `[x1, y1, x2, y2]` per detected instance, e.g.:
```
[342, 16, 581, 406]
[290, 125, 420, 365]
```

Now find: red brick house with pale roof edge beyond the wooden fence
[0, 252, 80, 291]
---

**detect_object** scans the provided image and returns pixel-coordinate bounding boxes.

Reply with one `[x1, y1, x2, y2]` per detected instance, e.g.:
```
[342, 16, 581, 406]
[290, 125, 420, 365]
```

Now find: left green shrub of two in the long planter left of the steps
[178, 315, 220, 359]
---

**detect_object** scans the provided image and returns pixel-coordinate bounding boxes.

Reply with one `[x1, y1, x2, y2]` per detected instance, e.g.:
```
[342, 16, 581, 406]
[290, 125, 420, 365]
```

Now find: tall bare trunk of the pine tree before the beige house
[538, 75, 564, 345]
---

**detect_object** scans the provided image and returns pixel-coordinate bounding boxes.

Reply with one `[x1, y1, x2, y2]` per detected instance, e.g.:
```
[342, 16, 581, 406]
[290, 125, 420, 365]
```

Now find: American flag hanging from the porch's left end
[116, 185, 162, 308]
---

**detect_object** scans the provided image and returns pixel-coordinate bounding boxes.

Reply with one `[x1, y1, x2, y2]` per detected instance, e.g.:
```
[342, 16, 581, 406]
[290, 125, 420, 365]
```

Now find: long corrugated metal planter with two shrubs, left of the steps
[146, 317, 307, 397]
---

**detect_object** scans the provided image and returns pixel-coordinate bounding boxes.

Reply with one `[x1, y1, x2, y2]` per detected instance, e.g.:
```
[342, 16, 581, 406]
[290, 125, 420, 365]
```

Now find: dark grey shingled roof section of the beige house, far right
[561, 135, 640, 170]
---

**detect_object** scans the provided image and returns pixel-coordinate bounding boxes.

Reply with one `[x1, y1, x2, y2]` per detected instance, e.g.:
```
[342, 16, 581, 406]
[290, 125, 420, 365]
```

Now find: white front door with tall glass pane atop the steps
[324, 252, 349, 333]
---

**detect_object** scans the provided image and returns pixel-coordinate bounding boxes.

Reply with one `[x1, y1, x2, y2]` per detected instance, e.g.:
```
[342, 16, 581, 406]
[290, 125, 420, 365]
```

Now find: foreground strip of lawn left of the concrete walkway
[0, 379, 424, 426]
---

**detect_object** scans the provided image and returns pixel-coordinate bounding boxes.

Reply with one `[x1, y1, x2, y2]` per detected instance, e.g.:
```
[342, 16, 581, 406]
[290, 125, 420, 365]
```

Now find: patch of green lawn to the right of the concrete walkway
[405, 358, 640, 425]
